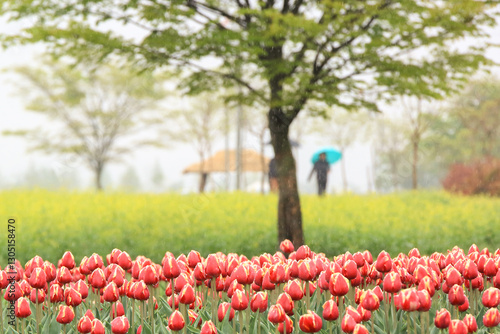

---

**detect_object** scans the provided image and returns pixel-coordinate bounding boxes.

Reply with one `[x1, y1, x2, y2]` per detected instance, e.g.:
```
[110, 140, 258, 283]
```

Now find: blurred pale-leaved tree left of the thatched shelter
[7, 62, 164, 190]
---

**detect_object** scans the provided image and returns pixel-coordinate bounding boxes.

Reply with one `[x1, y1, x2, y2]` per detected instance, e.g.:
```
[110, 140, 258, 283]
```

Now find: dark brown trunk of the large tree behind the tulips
[268, 107, 304, 248]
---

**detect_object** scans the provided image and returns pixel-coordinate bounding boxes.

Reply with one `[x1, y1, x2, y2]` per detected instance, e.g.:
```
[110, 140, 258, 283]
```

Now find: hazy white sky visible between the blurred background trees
[0, 15, 500, 192]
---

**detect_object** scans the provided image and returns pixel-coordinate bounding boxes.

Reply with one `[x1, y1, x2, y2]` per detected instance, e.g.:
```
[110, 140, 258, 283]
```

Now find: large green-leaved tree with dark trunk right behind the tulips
[2, 0, 495, 246]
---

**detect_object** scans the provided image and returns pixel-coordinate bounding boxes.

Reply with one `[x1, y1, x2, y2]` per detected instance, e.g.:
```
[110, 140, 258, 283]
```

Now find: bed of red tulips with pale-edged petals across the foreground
[0, 240, 500, 334]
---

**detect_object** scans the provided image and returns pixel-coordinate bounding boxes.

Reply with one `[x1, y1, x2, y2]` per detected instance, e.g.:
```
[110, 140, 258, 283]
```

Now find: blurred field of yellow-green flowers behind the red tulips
[0, 190, 500, 265]
